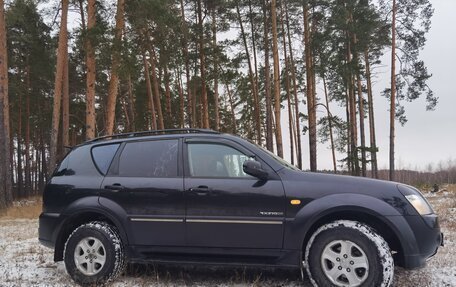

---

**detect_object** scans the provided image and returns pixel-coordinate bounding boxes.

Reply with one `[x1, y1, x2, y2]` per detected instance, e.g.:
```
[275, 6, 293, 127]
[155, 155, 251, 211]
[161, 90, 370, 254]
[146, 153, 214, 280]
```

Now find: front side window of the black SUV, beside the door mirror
[188, 143, 251, 178]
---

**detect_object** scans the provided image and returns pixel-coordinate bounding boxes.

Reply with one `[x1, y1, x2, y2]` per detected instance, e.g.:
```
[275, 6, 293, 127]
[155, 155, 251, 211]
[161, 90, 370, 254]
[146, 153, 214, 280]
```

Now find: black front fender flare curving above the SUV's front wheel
[284, 193, 418, 254]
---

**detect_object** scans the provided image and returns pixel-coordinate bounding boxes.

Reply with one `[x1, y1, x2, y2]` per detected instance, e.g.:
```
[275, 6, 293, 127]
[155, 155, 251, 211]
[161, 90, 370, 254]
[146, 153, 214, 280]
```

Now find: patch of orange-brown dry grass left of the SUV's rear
[0, 196, 42, 219]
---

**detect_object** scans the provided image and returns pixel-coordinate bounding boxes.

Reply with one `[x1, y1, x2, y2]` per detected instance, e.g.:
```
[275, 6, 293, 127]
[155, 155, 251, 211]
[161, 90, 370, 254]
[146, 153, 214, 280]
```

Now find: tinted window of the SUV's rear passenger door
[119, 140, 178, 177]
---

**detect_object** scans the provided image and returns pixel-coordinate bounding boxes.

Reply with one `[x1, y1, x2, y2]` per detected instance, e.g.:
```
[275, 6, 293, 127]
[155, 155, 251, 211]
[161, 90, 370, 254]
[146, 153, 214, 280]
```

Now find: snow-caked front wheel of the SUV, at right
[303, 220, 394, 287]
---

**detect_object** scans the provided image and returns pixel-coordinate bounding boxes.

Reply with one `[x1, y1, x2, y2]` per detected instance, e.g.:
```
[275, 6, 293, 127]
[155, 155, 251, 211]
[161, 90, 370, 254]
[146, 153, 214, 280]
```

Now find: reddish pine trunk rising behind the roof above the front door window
[198, 0, 209, 129]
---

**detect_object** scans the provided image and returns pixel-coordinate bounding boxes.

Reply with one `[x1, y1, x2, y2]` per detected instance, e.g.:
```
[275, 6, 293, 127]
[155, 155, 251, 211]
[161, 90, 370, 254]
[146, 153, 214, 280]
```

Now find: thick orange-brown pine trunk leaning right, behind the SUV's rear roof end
[105, 0, 125, 135]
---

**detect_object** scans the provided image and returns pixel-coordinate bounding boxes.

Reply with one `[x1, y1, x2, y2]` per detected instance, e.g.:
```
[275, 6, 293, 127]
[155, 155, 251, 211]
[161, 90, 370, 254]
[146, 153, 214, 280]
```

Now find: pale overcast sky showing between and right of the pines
[284, 0, 456, 170]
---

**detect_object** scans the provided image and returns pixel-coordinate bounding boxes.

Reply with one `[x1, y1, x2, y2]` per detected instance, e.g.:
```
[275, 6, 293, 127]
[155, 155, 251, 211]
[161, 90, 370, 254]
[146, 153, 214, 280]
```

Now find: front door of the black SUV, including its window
[184, 138, 285, 249]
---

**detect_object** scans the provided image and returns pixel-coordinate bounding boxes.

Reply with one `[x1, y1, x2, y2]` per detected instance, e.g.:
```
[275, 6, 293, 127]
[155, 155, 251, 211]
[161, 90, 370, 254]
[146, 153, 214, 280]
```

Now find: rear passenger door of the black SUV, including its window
[100, 138, 185, 246]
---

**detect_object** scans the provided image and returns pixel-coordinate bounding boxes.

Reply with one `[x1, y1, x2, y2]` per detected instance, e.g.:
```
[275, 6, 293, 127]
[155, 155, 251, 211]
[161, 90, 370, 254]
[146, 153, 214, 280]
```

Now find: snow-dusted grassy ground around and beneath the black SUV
[0, 191, 456, 287]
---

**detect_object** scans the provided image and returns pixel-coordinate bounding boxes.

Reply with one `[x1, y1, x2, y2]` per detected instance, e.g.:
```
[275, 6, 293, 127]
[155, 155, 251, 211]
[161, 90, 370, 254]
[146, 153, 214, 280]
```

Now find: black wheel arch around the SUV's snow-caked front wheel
[285, 193, 418, 266]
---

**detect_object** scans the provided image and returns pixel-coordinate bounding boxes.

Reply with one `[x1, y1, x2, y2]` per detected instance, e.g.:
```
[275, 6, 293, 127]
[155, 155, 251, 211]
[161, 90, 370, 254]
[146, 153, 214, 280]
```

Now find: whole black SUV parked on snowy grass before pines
[39, 129, 443, 286]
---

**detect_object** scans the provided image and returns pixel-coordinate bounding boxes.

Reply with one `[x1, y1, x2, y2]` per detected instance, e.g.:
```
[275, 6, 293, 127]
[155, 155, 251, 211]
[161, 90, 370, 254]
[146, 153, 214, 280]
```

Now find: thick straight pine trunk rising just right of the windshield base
[303, 3, 317, 172]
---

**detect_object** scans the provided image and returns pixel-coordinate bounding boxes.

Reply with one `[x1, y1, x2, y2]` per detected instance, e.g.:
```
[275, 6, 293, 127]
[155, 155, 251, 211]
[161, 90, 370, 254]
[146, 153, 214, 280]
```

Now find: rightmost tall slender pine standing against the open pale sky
[380, 0, 438, 180]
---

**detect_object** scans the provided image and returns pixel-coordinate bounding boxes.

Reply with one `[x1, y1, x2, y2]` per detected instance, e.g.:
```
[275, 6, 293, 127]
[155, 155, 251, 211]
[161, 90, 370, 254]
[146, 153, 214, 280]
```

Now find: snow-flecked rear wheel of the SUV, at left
[63, 221, 125, 286]
